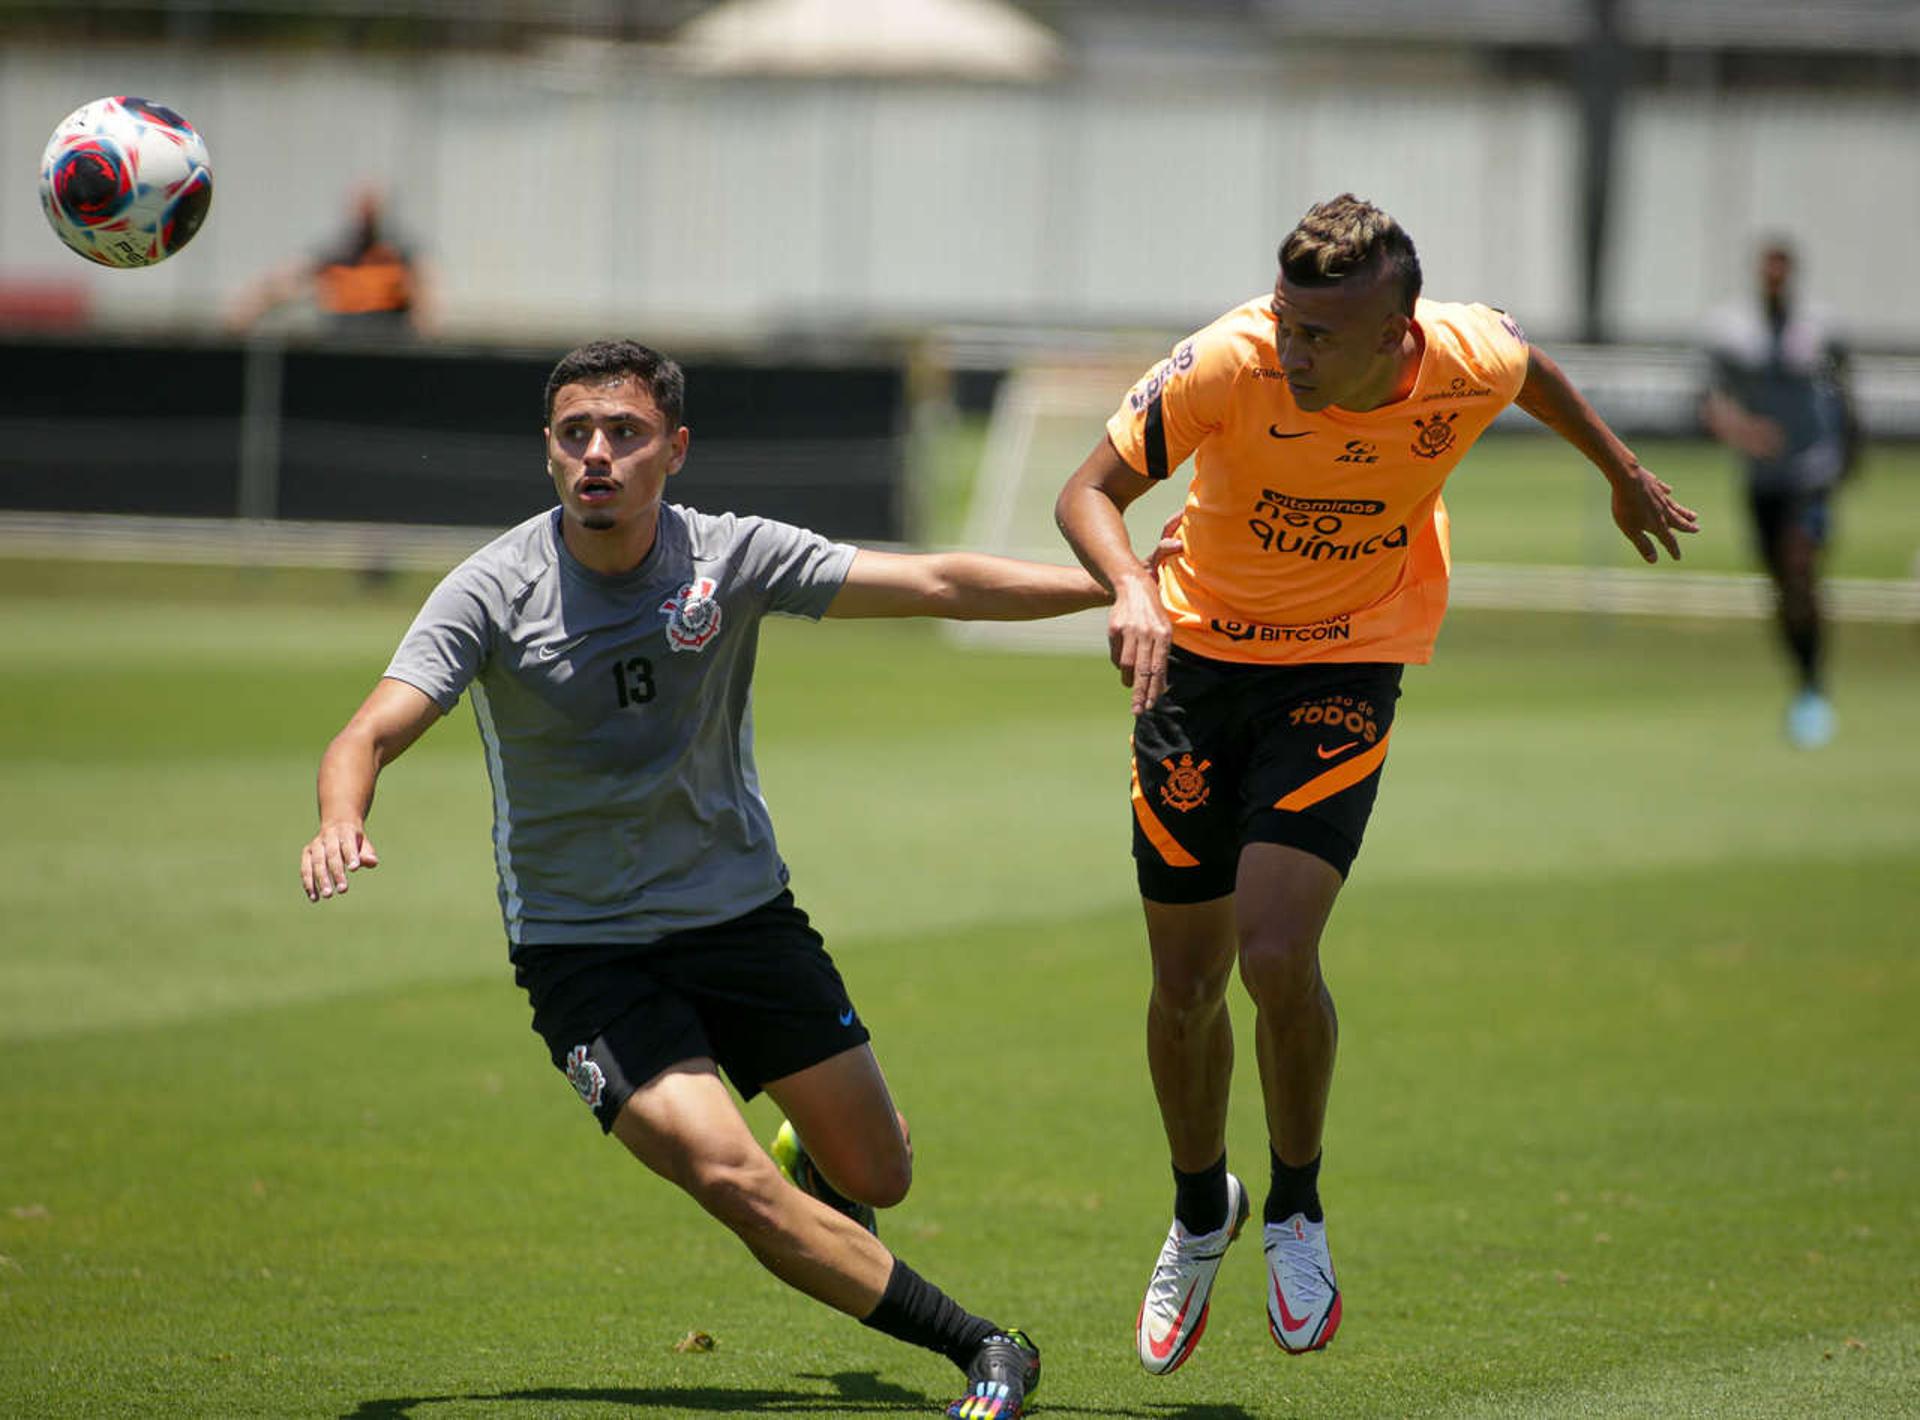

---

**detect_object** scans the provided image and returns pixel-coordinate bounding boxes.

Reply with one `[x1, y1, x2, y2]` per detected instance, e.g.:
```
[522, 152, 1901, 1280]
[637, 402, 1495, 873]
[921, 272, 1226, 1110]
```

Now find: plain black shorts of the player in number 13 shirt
[513, 892, 870, 1130]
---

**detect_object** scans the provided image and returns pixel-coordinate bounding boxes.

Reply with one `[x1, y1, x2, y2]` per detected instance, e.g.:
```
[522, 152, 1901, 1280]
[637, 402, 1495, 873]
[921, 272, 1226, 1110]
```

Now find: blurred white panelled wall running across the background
[0, 46, 1920, 345]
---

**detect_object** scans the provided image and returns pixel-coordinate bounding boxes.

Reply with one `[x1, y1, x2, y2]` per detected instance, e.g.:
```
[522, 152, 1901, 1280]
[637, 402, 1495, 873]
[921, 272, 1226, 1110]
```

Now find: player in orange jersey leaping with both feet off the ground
[1056, 194, 1697, 1372]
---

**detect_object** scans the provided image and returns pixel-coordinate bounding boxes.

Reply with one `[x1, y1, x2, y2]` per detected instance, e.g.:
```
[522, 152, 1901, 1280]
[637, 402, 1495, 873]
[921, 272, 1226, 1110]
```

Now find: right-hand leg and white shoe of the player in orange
[1235, 842, 1342, 1353]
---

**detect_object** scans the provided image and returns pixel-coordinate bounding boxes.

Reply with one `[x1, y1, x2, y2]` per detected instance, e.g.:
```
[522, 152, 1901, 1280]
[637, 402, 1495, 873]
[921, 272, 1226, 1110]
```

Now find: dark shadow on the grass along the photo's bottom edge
[342, 1370, 1258, 1420]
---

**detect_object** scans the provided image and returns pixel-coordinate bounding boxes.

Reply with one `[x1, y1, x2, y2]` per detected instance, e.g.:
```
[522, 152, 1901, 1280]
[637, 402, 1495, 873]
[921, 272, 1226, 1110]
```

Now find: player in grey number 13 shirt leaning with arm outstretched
[300, 342, 1108, 1420]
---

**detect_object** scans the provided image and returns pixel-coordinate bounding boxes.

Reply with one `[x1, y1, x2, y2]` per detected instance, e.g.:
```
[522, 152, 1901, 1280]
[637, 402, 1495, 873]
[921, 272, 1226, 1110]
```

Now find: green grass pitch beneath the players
[0, 473, 1920, 1420]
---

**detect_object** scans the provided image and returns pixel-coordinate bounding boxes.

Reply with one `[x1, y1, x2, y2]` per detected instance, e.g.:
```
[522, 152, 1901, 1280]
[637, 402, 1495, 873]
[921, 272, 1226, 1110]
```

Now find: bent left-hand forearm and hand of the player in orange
[1054, 438, 1173, 714]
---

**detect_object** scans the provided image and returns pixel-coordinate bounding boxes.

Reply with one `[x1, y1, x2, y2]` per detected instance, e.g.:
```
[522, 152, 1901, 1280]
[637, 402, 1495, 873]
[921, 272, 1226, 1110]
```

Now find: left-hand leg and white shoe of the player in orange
[1135, 898, 1250, 1374]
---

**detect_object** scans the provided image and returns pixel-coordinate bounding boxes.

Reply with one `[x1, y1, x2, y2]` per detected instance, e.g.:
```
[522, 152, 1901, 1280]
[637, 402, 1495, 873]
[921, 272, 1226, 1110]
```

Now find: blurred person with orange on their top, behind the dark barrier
[228, 184, 438, 338]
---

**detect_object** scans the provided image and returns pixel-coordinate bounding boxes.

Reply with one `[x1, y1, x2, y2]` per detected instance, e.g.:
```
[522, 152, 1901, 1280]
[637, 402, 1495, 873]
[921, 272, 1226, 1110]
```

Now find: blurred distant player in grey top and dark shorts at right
[1701, 238, 1860, 748]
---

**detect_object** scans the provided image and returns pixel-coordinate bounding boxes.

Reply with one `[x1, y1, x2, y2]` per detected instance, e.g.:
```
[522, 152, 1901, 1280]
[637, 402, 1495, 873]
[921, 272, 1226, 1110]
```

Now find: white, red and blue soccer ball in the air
[40, 96, 213, 267]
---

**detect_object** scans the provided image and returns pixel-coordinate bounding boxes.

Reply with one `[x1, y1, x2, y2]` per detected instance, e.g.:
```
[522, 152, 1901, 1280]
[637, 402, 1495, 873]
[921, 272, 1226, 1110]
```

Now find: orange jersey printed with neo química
[1106, 296, 1526, 662]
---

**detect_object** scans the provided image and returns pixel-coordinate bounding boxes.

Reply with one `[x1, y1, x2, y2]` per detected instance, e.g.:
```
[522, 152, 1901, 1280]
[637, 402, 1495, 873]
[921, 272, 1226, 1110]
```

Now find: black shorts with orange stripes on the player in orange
[1133, 647, 1404, 902]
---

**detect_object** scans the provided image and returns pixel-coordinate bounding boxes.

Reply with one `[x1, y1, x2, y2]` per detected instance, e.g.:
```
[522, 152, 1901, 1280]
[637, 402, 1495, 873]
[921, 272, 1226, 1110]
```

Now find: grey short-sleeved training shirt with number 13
[386, 505, 854, 946]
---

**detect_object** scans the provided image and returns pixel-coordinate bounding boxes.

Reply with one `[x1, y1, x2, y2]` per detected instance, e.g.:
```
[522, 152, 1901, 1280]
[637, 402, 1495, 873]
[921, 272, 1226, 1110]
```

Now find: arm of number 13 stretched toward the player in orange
[828, 547, 1108, 622]
